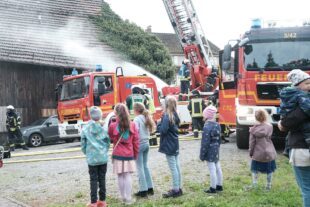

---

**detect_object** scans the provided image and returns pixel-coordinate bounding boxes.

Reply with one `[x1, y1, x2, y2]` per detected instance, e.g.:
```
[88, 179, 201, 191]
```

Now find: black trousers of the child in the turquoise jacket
[88, 164, 107, 203]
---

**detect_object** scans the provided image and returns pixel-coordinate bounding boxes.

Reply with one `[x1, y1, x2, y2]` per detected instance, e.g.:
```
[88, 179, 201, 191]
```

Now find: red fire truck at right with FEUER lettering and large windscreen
[219, 20, 310, 149]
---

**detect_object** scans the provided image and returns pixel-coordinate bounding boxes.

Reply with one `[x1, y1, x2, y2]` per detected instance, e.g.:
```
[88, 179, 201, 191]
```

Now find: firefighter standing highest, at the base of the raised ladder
[179, 59, 190, 101]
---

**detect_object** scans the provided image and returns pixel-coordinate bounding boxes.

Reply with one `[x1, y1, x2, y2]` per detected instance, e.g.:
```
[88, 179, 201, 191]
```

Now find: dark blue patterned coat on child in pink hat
[200, 121, 221, 162]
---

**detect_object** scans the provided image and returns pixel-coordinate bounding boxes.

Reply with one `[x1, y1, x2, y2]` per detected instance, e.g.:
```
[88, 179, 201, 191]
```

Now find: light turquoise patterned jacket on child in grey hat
[81, 120, 110, 166]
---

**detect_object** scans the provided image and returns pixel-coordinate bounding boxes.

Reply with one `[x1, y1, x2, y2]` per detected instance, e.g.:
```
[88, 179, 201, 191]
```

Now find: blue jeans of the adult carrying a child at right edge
[294, 166, 310, 207]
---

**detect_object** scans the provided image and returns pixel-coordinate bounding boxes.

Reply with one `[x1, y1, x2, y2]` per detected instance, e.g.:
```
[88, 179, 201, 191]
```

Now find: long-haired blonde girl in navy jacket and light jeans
[158, 96, 183, 198]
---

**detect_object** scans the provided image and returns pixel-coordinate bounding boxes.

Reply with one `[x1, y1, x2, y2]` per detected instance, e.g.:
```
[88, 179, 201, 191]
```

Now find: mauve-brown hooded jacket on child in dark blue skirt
[249, 123, 277, 162]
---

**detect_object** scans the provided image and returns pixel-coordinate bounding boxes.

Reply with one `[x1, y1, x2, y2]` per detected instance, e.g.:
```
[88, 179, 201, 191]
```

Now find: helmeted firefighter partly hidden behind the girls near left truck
[126, 85, 149, 119]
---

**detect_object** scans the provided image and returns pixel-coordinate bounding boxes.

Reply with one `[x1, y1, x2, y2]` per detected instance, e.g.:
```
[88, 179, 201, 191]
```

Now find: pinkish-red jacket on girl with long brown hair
[108, 122, 139, 160]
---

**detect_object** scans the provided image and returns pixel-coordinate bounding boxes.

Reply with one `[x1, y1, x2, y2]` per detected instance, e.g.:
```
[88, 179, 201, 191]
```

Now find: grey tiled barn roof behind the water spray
[0, 0, 120, 69]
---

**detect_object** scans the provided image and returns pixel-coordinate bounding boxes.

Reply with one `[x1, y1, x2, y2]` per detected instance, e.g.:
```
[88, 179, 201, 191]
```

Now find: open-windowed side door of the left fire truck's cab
[93, 75, 117, 111]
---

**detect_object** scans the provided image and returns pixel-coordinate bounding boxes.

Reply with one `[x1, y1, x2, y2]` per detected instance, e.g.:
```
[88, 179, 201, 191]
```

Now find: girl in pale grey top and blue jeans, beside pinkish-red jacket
[133, 103, 155, 197]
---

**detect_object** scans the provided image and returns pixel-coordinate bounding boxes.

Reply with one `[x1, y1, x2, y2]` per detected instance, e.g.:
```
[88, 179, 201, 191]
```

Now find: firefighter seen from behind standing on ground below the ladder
[187, 90, 206, 138]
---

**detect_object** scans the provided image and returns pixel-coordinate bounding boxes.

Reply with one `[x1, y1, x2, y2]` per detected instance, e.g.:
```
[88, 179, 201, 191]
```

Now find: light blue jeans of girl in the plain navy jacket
[166, 155, 182, 190]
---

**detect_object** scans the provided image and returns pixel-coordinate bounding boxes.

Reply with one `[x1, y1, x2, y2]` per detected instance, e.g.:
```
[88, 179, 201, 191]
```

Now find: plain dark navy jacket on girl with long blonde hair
[157, 113, 180, 156]
